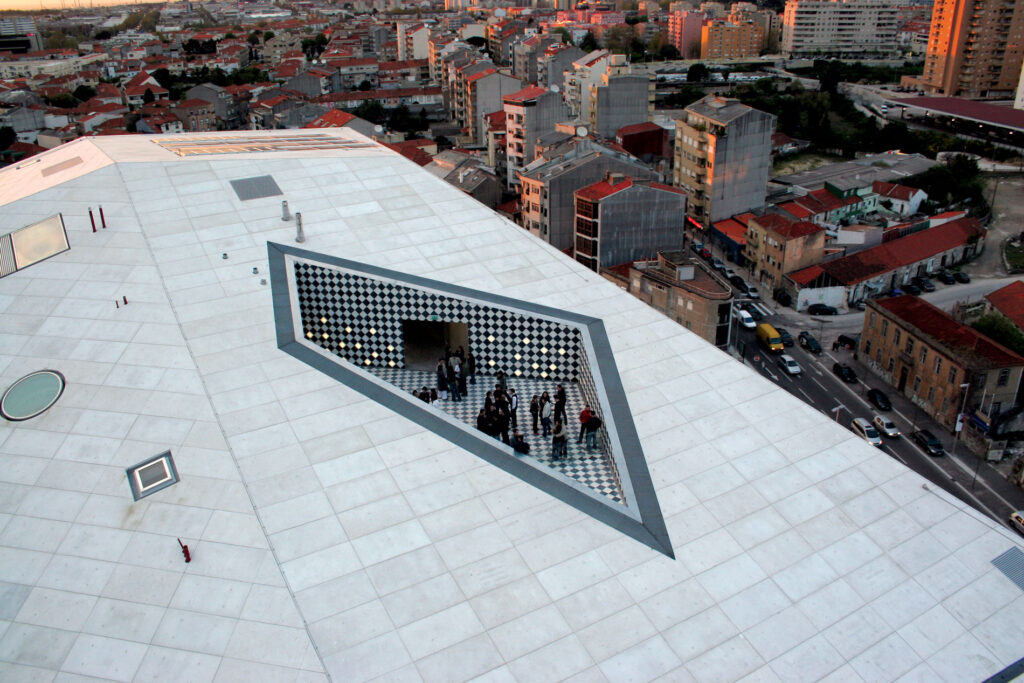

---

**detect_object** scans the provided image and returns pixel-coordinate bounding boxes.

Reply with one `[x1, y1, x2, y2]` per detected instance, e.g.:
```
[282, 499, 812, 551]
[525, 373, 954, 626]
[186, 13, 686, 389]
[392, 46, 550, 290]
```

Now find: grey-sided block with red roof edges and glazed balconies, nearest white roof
[573, 173, 686, 272]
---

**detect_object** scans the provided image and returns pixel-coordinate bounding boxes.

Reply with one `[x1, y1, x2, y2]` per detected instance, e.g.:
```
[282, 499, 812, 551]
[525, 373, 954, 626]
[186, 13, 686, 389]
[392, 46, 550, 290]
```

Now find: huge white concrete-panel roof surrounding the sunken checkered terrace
[0, 129, 1024, 683]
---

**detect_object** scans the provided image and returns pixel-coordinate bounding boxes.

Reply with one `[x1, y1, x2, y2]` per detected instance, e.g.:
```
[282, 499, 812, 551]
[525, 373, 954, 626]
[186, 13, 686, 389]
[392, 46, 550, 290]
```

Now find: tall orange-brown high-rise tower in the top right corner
[921, 0, 1024, 98]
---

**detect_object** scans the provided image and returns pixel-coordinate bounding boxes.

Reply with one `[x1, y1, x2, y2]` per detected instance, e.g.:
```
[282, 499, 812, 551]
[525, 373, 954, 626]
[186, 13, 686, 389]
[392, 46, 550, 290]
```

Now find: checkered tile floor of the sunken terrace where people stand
[367, 368, 623, 502]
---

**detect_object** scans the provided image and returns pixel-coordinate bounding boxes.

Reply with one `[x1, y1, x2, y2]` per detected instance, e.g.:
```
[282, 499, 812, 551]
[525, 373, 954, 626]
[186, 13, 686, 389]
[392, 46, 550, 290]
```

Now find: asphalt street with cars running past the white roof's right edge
[738, 316, 1024, 524]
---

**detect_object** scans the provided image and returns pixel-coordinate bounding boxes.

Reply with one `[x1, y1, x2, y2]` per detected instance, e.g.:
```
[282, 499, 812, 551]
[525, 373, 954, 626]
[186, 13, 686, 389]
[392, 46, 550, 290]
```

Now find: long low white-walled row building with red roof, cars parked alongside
[785, 217, 986, 310]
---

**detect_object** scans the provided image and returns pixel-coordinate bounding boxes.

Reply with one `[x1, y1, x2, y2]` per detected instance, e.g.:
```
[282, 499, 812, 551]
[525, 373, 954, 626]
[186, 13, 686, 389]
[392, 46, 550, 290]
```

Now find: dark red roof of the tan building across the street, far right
[870, 294, 1024, 368]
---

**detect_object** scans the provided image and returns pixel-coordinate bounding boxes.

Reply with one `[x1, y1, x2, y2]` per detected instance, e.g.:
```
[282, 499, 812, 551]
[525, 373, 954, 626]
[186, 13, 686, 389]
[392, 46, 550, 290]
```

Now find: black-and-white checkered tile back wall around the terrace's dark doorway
[295, 261, 596, 382]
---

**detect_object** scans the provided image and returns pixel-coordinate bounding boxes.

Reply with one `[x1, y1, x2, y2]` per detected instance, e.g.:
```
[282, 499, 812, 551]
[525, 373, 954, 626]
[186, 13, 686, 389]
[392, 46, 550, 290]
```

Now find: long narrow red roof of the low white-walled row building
[821, 218, 985, 285]
